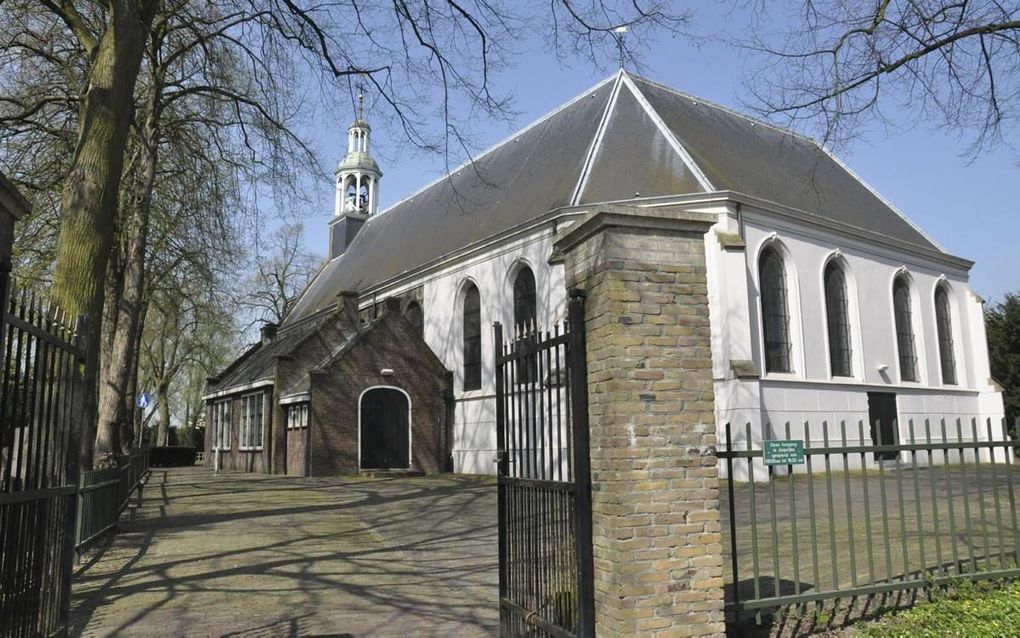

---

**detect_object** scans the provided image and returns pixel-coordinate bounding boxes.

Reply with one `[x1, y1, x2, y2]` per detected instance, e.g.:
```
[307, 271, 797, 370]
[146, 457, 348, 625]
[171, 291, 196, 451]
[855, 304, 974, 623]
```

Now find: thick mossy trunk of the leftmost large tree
[53, 0, 157, 468]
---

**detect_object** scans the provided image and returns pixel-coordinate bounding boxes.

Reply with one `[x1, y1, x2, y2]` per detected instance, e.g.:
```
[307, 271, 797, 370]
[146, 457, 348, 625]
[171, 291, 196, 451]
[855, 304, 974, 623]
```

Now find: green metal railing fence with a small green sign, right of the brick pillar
[718, 420, 1020, 621]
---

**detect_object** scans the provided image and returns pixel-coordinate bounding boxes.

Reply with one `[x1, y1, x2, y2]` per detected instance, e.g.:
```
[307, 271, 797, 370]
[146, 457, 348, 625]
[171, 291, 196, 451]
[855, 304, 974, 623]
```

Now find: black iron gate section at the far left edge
[0, 283, 85, 636]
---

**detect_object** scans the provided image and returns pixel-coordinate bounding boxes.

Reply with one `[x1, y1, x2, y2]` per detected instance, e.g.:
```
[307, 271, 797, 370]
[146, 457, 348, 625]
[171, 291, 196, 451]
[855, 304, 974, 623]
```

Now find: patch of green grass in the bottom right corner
[854, 581, 1020, 638]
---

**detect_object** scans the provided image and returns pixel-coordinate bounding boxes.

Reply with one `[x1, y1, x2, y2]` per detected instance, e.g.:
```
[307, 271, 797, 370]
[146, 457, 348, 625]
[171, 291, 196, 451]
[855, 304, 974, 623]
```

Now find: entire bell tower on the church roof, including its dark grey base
[329, 95, 383, 258]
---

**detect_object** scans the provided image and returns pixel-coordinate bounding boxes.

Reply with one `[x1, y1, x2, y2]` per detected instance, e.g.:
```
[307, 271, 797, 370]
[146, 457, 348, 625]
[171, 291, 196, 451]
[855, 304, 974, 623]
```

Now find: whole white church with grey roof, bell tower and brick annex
[205, 70, 1003, 476]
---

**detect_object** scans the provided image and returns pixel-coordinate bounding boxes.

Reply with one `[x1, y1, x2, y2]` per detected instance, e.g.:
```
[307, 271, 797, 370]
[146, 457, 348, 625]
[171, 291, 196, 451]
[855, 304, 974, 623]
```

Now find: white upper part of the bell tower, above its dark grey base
[335, 95, 383, 217]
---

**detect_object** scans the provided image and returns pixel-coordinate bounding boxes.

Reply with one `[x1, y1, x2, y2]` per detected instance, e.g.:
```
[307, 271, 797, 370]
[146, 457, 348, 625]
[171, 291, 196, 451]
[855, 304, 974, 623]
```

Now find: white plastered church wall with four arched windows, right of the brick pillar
[726, 209, 1003, 479]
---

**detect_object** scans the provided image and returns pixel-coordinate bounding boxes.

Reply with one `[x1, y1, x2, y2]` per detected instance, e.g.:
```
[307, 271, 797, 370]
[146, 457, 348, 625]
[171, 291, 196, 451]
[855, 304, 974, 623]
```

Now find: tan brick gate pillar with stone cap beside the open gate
[556, 206, 725, 636]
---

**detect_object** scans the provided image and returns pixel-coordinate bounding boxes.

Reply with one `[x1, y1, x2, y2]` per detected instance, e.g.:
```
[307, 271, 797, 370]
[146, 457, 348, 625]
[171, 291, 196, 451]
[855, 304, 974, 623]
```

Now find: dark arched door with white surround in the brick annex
[361, 388, 411, 470]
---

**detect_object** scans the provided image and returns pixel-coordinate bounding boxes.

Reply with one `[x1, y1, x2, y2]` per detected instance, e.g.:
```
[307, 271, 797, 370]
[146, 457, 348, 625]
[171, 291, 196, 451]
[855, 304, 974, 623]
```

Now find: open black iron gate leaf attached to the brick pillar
[494, 291, 595, 637]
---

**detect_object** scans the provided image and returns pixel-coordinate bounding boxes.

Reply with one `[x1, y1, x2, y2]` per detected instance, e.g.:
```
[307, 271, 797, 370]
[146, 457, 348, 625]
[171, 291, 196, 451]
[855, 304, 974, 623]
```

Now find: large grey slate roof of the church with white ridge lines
[285, 73, 938, 326]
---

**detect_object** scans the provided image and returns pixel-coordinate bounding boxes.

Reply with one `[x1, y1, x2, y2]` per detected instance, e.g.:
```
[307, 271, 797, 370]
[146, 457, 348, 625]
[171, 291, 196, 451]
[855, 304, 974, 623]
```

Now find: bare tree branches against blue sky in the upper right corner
[750, 0, 1020, 156]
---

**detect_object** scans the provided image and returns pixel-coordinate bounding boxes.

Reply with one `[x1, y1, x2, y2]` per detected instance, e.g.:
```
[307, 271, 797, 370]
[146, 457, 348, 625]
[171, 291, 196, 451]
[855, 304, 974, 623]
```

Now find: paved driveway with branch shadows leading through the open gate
[71, 469, 498, 637]
